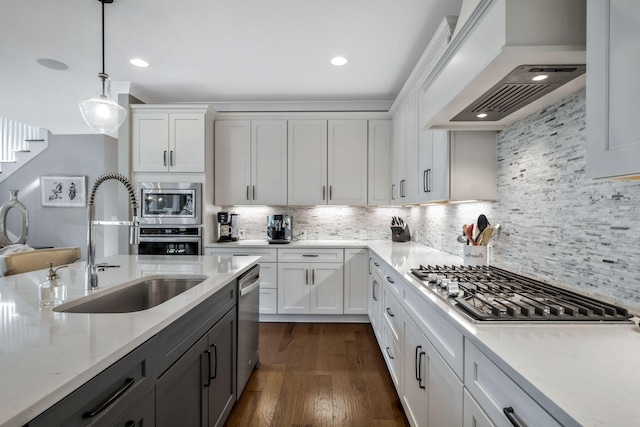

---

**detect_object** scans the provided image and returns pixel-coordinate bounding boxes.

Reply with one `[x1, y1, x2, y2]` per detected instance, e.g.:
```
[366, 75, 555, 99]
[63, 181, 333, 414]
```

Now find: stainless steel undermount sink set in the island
[53, 275, 208, 313]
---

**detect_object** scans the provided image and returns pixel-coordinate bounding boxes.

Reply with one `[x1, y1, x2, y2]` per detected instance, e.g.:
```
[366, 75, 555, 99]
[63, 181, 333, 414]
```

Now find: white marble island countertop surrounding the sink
[0, 256, 258, 427]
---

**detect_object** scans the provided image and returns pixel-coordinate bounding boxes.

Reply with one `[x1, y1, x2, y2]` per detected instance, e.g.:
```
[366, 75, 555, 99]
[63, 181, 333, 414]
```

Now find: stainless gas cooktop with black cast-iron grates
[411, 265, 631, 322]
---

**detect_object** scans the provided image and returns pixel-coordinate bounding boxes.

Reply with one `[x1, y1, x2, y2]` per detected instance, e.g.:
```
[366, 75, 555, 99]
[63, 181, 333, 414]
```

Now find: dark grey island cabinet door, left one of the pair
[156, 335, 209, 427]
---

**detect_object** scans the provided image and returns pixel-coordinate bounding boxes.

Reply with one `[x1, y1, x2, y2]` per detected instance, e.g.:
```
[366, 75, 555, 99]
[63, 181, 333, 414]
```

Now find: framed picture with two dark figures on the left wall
[40, 175, 87, 208]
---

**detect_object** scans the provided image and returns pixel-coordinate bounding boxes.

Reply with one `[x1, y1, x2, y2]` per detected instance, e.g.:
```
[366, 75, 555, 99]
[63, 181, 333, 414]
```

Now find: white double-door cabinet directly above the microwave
[131, 104, 213, 173]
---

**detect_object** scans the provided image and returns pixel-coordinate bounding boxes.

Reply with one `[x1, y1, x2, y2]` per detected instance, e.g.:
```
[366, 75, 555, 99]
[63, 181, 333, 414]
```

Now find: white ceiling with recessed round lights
[0, 0, 462, 134]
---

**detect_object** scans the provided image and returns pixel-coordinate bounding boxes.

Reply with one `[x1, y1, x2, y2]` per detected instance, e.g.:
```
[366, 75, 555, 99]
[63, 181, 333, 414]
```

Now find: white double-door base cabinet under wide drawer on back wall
[278, 262, 344, 314]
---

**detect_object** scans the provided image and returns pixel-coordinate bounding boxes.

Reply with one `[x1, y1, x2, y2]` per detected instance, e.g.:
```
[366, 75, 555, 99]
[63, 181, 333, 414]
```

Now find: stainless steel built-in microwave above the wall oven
[137, 182, 202, 225]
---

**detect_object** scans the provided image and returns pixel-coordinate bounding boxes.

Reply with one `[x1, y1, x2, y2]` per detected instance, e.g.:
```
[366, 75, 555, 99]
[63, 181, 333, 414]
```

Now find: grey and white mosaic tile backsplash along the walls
[218, 89, 640, 312]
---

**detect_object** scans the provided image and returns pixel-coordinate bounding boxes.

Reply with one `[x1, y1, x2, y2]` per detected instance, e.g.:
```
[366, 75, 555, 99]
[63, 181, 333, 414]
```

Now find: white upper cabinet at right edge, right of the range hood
[586, 0, 640, 178]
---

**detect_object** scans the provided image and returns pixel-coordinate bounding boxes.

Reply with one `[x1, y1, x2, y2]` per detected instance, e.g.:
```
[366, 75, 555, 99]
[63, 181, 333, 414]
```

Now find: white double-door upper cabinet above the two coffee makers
[215, 120, 287, 205]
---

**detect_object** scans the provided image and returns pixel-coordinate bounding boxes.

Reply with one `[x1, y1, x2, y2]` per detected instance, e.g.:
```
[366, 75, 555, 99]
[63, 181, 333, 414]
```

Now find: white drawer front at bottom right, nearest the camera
[464, 340, 561, 427]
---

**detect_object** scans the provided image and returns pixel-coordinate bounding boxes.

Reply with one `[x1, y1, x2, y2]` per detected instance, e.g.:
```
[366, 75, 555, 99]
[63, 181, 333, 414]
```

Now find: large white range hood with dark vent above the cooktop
[419, 0, 586, 130]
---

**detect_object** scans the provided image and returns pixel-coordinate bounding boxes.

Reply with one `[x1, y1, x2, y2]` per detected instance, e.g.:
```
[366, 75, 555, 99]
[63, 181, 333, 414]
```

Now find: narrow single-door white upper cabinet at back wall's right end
[368, 120, 391, 206]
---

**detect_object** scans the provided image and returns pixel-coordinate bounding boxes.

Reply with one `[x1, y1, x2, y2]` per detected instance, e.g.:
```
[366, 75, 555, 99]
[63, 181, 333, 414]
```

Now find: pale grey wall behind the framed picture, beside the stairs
[0, 135, 118, 259]
